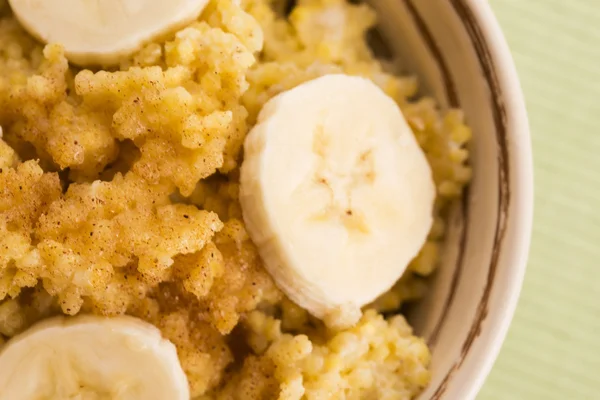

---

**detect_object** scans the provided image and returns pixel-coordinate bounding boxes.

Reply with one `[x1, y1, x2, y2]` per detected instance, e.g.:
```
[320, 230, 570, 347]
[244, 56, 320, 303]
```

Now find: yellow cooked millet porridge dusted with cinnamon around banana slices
[0, 0, 471, 400]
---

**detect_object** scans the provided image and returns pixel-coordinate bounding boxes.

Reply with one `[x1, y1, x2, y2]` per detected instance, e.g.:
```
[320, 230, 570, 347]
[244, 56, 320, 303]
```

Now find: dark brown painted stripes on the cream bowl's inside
[403, 0, 510, 400]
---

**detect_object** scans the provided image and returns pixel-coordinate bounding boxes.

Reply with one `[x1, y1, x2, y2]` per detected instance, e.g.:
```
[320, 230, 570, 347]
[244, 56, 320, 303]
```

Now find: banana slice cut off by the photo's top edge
[9, 0, 208, 65]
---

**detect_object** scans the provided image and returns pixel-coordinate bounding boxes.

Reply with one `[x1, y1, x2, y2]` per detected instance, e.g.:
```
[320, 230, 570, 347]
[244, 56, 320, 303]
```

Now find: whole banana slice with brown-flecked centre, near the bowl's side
[240, 75, 435, 328]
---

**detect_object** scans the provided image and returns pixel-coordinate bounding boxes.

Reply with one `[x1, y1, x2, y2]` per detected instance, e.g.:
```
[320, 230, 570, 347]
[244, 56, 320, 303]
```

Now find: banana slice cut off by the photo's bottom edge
[0, 316, 190, 400]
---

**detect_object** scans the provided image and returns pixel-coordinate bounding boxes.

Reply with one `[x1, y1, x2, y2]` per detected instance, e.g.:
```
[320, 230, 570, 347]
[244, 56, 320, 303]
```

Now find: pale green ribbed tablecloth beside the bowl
[480, 0, 600, 400]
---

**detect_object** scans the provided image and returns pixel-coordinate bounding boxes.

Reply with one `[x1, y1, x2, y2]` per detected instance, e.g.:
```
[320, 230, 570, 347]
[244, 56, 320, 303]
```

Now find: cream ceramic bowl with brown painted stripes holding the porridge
[370, 0, 533, 400]
